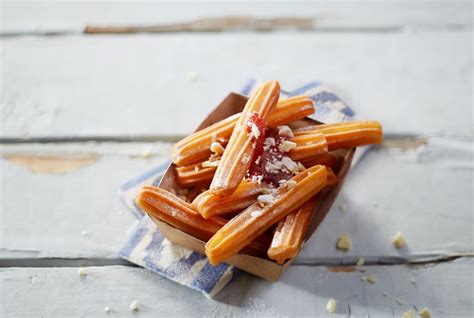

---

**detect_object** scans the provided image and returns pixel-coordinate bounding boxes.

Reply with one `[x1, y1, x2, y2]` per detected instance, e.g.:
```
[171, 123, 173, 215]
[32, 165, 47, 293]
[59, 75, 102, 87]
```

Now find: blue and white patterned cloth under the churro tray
[119, 80, 354, 297]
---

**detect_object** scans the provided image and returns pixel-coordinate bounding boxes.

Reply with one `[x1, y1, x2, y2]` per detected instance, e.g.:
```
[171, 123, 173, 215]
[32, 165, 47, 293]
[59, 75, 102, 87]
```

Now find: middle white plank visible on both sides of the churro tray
[0, 137, 474, 264]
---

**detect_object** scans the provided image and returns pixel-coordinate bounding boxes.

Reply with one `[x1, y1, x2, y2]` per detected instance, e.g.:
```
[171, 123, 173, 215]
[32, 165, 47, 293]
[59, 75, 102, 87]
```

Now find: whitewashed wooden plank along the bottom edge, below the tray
[0, 258, 474, 317]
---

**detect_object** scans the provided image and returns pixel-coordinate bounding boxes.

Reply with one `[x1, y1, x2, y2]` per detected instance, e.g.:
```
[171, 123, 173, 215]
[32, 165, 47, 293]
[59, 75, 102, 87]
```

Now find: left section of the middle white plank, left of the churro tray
[0, 143, 169, 259]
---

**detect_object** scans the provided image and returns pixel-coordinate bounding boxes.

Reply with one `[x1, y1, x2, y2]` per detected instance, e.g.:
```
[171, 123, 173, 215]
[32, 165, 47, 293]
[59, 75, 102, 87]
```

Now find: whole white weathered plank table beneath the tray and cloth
[0, 0, 474, 317]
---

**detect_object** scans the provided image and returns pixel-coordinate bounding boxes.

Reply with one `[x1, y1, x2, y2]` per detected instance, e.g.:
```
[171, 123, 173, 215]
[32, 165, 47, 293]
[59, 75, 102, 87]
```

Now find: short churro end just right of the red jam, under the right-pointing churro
[290, 132, 328, 161]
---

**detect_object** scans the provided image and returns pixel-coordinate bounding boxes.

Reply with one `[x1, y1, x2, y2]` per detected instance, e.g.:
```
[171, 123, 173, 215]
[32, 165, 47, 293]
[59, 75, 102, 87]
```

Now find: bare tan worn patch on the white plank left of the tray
[3, 154, 99, 174]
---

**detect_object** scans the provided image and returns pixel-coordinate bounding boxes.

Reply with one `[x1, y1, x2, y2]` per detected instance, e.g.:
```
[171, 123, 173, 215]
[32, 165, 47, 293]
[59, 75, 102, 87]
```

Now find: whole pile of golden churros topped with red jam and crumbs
[136, 81, 383, 265]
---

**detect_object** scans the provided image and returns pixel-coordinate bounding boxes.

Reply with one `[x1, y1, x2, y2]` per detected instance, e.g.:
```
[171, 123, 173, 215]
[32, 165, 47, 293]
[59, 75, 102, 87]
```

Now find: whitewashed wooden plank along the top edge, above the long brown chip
[1, 1, 472, 34]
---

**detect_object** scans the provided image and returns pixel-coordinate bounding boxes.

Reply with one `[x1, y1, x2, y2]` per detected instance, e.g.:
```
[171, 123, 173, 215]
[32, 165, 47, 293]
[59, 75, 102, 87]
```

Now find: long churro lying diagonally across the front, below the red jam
[206, 166, 327, 265]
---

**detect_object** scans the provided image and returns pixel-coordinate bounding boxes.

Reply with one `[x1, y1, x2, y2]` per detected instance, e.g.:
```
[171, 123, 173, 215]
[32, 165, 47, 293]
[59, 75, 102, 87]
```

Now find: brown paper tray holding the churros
[150, 93, 354, 282]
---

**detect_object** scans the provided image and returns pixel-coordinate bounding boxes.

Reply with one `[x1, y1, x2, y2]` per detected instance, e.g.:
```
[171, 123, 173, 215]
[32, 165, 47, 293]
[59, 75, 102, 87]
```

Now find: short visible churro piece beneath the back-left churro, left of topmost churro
[175, 161, 218, 187]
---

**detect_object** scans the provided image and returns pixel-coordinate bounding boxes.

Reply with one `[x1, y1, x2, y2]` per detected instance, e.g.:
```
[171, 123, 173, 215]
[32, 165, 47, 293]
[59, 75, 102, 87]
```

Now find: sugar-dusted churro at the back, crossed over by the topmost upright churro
[172, 96, 314, 166]
